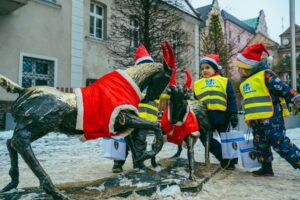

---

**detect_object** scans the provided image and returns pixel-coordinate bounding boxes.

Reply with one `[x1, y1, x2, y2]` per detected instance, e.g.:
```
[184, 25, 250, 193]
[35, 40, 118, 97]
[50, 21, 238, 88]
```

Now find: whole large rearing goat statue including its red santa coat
[0, 41, 175, 200]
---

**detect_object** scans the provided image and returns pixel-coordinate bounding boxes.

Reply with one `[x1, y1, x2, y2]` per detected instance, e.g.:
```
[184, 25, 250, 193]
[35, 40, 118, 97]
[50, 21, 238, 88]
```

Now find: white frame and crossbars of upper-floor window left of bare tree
[89, 1, 106, 40]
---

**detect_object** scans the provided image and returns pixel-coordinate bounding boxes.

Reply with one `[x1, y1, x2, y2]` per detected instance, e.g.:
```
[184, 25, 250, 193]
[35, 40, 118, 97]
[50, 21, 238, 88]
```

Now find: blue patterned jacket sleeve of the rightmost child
[265, 70, 297, 102]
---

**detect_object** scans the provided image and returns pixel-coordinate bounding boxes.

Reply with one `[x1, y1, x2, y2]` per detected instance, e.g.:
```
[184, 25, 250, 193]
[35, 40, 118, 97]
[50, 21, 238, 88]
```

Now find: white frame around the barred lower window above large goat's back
[18, 52, 57, 87]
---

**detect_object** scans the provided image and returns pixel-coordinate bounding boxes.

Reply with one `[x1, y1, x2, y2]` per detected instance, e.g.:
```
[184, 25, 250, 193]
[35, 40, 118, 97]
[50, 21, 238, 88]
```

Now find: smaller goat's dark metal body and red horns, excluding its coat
[151, 69, 212, 180]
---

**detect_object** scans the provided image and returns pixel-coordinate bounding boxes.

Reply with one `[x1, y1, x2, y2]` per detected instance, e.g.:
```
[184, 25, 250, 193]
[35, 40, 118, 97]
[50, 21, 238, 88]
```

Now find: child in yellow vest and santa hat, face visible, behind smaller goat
[194, 54, 238, 170]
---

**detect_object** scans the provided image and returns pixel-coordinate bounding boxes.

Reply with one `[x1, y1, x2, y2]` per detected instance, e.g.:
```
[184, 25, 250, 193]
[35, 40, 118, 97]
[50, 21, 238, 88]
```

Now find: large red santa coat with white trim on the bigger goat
[75, 70, 143, 140]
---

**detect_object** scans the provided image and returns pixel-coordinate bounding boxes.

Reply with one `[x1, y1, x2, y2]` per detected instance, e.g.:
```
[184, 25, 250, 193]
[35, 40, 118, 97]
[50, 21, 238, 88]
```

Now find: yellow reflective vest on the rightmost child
[240, 70, 289, 122]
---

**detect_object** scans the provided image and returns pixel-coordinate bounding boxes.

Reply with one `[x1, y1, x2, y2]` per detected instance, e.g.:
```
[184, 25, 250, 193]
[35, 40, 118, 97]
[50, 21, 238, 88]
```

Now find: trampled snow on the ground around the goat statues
[0, 128, 300, 200]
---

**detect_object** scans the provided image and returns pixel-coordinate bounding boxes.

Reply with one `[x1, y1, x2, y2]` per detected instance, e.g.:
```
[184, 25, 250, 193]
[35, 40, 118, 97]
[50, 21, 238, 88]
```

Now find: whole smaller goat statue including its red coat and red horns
[151, 68, 211, 180]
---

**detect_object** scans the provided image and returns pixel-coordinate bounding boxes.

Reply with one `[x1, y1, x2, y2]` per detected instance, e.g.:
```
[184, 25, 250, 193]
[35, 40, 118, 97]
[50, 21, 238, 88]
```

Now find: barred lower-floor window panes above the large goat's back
[22, 56, 54, 88]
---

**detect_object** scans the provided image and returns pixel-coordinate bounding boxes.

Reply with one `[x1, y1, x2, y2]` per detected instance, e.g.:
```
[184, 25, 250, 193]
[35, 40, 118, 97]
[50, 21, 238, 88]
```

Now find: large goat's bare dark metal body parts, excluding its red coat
[0, 42, 174, 199]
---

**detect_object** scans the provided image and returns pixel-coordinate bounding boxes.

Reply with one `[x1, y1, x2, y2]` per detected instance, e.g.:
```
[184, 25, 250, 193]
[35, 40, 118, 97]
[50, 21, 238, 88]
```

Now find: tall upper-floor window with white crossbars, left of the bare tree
[90, 3, 104, 39]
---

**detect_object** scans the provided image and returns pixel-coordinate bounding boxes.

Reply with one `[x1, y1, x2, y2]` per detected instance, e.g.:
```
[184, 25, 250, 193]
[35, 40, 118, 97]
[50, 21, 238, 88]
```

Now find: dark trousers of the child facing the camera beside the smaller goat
[200, 125, 238, 164]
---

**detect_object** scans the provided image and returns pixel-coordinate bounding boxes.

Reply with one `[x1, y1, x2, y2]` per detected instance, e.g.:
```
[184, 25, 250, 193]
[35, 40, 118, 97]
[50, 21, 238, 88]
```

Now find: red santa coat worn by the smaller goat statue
[160, 106, 200, 145]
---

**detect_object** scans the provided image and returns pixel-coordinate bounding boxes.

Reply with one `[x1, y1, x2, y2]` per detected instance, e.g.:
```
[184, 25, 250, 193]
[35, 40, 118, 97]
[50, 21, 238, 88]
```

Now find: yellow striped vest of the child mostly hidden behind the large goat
[138, 100, 158, 122]
